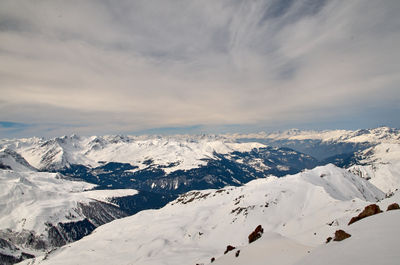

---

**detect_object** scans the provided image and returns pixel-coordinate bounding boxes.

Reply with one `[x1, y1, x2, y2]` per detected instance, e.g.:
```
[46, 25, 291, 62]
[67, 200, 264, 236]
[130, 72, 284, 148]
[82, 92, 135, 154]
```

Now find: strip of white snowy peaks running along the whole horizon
[0, 127, 400, 173]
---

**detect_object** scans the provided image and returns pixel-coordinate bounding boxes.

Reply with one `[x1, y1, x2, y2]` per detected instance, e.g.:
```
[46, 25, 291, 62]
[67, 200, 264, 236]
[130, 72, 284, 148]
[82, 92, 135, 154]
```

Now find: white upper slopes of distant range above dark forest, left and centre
[0, 135, 265, 172]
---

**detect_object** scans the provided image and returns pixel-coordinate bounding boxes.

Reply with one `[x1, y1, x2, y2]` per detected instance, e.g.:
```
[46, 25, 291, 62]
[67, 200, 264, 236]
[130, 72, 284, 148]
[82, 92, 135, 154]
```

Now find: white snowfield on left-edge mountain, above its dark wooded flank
[0, 170, 137, 234]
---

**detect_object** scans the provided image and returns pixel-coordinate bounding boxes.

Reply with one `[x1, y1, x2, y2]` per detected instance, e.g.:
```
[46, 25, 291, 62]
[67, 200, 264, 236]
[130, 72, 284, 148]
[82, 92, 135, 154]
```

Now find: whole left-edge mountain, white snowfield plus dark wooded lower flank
[0, 170, 137, 264]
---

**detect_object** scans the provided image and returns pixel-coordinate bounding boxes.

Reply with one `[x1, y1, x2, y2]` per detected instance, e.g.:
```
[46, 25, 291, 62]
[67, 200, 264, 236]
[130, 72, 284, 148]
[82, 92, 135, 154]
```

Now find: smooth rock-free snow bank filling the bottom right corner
[295, 210, 400, 265]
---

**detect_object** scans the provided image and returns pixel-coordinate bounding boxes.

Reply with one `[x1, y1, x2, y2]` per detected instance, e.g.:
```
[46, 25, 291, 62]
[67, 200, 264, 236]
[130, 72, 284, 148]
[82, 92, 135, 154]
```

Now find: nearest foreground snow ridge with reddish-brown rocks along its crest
[212, 193, 400, 265]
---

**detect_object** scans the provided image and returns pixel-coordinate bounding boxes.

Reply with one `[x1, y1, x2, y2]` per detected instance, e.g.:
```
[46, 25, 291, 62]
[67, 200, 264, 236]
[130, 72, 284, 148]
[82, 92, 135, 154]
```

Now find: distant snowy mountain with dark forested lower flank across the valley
[0, 135, 318, 194]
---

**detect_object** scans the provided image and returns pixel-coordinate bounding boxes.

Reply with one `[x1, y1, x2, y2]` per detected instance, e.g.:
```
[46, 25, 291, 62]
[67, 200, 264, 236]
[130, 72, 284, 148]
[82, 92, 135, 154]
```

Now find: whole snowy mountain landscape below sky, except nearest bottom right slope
[0, 127, 400, 264]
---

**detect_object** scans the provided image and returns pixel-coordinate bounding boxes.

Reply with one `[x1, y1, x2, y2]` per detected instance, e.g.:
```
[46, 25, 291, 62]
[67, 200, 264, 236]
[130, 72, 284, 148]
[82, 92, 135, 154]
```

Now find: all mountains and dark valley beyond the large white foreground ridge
[0, 127, 400, 264]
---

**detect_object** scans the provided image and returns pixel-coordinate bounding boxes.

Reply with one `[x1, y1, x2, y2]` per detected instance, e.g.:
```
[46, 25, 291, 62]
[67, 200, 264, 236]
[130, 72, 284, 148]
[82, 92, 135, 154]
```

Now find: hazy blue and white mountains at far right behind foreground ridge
[233, 127, 400, 193]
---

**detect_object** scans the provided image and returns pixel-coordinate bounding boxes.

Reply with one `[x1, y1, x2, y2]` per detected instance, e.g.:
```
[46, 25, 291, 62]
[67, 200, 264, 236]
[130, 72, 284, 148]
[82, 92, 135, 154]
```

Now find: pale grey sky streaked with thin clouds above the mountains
[0, 0, 400, 138]
